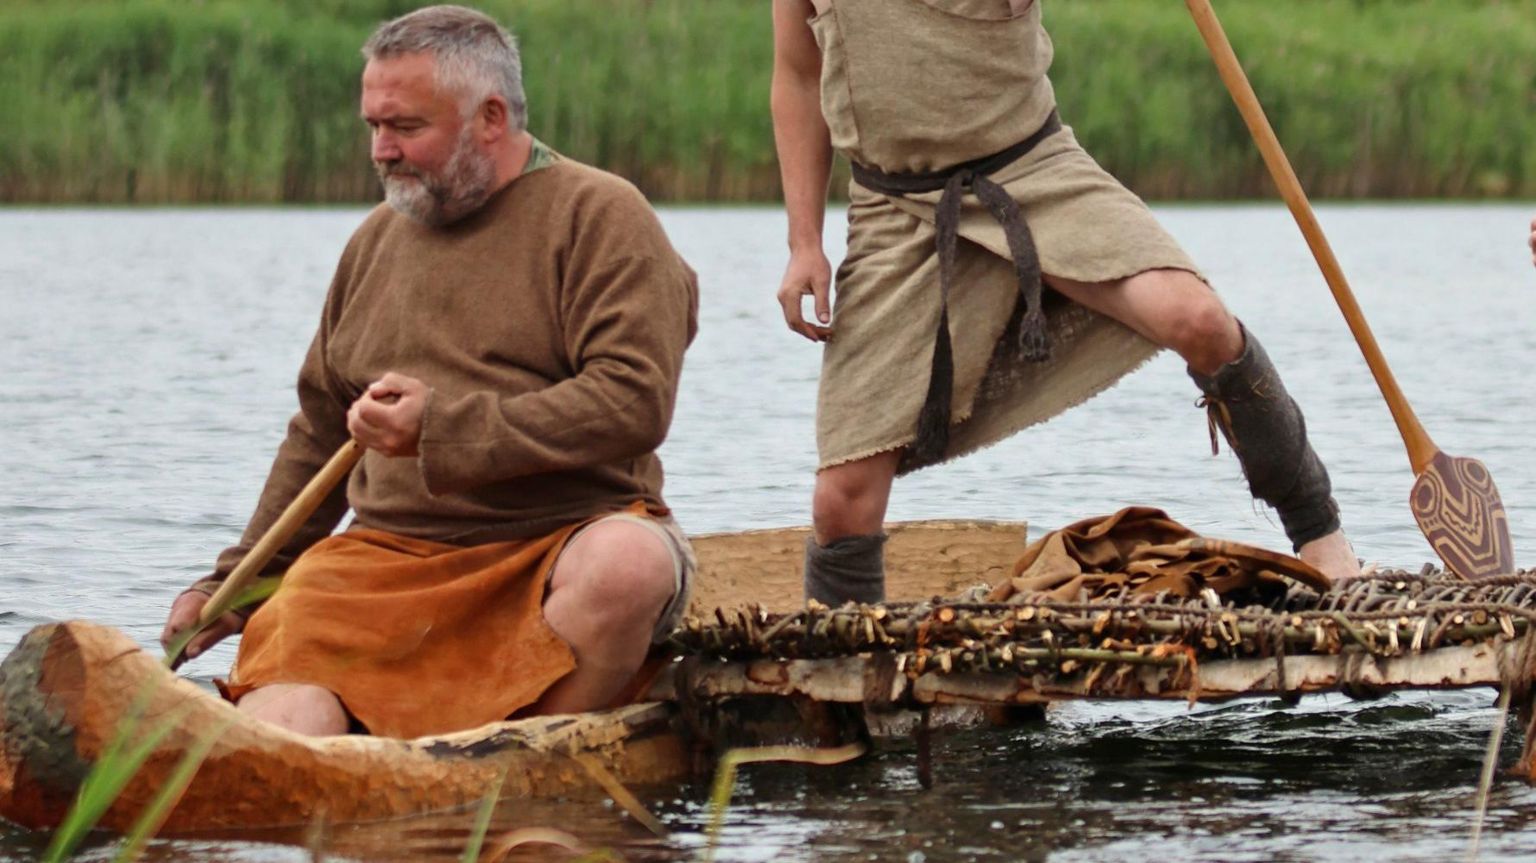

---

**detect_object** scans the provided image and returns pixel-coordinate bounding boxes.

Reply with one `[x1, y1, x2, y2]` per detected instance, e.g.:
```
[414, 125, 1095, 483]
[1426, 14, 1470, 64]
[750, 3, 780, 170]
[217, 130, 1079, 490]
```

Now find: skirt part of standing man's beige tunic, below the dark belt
[816, 127, 1198, 473]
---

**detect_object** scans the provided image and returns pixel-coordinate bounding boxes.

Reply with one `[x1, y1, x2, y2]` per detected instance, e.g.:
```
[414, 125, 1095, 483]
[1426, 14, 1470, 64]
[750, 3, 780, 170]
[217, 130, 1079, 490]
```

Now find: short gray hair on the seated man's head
[362, 6, 528, 132]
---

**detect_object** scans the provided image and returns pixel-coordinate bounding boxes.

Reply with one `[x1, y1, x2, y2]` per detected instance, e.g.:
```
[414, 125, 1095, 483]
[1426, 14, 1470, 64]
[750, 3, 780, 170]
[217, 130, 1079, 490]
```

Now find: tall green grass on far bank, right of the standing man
[1046, 0, 1536, 198]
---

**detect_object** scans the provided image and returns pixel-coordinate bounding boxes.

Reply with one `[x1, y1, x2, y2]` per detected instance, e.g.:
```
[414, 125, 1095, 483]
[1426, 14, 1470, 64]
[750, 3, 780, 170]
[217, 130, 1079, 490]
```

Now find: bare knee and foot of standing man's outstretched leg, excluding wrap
[1046, 270, 1359, 580]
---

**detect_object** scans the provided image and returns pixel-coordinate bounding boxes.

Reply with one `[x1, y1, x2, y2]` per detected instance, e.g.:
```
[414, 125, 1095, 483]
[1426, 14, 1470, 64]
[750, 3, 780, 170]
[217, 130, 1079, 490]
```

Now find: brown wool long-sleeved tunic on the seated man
[196, 158, 697, 589]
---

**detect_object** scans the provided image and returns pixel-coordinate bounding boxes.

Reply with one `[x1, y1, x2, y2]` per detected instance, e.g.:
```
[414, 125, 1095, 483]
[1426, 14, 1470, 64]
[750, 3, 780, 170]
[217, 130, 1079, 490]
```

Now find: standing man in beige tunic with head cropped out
[773, 0, 1359, 603]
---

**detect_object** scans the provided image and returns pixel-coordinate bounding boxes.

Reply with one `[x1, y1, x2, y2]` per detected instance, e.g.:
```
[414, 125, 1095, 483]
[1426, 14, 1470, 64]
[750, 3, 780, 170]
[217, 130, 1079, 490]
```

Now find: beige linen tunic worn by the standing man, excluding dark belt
[809, 0, 1198, 473]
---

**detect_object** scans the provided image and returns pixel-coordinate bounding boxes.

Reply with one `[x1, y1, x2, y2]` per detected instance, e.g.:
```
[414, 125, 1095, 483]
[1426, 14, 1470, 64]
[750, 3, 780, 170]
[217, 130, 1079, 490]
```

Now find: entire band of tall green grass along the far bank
[0, 0, 1536, 203]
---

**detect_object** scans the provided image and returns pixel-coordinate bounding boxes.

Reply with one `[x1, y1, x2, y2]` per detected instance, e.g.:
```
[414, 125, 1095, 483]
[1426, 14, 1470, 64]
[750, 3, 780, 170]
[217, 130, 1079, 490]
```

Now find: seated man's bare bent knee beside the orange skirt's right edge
[533, 521, 677, 714]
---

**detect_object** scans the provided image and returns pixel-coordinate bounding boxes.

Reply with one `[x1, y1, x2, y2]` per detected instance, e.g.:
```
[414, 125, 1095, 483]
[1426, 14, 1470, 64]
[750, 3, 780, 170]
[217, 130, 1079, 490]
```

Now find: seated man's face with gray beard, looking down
[362, 54, 495, 227]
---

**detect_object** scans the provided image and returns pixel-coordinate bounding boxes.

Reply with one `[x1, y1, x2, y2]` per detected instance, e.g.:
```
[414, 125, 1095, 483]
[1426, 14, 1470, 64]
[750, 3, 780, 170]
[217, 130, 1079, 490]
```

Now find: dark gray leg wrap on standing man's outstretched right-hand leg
[1189, 329, 1339, 548]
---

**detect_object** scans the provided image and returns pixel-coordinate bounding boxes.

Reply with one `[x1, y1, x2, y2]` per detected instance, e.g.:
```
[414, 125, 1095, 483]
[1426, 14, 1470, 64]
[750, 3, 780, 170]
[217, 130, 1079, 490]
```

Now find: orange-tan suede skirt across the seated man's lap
[221, 504, 666, 737]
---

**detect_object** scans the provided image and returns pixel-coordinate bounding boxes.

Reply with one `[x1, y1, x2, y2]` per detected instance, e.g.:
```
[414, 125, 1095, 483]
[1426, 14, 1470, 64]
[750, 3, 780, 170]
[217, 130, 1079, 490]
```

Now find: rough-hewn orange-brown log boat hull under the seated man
[0, 622, 687, 832]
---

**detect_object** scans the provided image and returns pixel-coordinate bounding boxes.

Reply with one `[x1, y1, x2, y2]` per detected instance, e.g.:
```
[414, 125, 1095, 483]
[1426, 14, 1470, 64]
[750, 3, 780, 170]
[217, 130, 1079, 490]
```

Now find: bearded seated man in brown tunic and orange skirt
[163, 6, 697, 737]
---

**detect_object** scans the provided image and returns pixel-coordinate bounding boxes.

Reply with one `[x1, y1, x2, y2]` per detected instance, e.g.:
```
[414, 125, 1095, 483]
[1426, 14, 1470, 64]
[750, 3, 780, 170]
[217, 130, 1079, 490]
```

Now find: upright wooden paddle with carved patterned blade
[1184, 0, 1514, 579]
